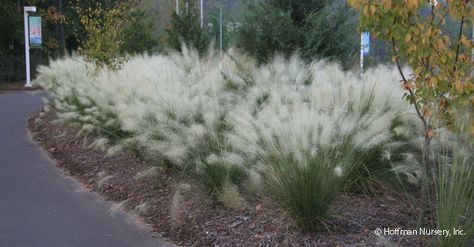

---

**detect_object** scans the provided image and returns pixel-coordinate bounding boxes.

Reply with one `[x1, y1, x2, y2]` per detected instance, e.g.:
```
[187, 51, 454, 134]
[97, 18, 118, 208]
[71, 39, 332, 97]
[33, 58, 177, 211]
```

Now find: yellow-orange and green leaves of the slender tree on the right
[349, 0, 474, 135]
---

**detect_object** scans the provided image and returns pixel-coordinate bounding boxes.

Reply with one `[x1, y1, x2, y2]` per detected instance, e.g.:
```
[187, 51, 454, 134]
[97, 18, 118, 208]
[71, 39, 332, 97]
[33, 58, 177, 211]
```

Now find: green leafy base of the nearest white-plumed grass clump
[264, 149, 344, 232]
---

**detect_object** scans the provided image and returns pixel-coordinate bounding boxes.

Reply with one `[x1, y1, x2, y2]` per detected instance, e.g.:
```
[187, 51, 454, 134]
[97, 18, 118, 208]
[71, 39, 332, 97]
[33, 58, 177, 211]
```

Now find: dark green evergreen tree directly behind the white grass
[237, 0, 358, 67]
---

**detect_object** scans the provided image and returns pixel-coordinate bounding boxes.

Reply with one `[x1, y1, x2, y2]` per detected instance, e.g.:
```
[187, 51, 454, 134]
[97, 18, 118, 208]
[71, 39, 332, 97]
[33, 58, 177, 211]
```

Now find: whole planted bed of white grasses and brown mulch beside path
[30, 47, 474, 246]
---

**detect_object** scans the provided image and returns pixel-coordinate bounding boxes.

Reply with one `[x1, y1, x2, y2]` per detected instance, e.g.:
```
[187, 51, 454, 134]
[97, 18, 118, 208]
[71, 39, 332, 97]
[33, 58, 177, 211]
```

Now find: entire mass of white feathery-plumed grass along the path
[37, 47, 419, 231]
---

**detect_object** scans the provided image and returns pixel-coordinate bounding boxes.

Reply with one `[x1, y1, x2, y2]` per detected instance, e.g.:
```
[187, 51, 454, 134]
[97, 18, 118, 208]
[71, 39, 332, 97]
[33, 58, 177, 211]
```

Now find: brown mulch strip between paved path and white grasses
[28, 110, 422, 246]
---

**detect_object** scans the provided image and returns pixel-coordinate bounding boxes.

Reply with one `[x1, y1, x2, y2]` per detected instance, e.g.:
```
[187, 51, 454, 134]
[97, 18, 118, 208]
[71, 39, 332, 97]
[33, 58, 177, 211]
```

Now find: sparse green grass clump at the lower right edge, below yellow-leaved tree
[433, 126, 474, 247]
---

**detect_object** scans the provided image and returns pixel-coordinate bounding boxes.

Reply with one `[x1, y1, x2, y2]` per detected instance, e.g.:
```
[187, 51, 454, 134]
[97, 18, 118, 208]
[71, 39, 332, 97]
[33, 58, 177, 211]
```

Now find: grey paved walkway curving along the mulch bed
[0, 92, 169, 247]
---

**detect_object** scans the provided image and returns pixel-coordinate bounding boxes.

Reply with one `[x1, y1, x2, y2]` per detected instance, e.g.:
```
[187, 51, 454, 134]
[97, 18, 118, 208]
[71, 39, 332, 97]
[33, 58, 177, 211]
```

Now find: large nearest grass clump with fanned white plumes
[228, 57, 419, 231]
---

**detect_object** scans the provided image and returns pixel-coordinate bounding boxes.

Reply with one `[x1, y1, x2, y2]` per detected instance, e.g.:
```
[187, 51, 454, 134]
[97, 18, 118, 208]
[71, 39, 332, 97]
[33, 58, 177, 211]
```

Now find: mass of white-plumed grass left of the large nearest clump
[37, 47, 253, 201]
